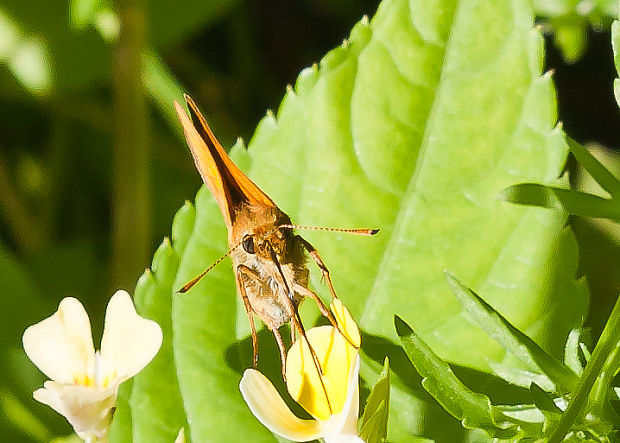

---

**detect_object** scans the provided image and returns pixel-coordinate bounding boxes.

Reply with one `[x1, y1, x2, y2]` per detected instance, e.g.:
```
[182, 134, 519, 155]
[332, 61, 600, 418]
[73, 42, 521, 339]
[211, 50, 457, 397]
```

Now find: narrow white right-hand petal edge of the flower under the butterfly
[324, 354, 361, 442]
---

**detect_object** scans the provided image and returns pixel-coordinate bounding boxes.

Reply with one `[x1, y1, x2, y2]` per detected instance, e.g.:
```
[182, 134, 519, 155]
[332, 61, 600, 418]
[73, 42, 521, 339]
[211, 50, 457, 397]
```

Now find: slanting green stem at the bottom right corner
[549, 298, 620, 443]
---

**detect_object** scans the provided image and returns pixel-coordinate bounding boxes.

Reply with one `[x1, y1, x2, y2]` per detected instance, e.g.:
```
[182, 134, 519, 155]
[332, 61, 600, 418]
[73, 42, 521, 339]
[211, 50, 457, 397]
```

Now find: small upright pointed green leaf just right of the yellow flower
[360, 357, 390, 443]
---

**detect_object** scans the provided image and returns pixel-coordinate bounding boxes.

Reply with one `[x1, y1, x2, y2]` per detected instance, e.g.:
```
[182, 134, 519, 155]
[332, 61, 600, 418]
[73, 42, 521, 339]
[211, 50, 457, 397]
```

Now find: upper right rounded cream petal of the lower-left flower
[101, 290, 162, 386]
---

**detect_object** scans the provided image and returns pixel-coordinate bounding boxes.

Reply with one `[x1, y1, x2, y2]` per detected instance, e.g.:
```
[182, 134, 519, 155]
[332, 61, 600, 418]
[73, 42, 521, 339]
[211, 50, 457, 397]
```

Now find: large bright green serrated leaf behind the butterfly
[118, 0, 585, 441]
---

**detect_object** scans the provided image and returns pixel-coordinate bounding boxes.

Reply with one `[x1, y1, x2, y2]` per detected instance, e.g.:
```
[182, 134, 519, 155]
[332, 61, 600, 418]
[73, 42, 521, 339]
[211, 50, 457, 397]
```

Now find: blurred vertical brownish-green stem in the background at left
[112, 0, 150, 287]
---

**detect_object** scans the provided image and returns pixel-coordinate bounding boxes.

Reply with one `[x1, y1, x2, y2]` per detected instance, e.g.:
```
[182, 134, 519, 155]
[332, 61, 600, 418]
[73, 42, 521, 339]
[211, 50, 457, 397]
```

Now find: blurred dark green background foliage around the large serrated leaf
[0, 0, 620, 441]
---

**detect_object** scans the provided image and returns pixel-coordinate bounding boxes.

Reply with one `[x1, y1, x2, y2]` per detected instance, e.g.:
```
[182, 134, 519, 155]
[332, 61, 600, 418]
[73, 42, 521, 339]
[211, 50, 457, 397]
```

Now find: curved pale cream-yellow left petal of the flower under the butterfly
[239, 369, 324, 441]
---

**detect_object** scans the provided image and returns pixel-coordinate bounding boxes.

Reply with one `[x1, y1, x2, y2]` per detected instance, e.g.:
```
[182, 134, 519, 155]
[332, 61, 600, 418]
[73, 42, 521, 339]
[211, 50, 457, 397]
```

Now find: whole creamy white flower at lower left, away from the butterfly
[22, 290, 162, 441]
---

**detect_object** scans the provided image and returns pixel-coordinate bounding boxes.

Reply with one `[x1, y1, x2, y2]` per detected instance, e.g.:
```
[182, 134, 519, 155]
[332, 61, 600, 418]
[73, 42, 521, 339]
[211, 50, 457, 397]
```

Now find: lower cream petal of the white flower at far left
[34, 381, 116, 439]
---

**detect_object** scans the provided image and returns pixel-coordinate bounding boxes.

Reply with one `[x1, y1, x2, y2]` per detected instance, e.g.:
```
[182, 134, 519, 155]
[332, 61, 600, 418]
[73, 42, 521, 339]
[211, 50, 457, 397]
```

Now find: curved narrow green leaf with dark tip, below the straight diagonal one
[394, 316, 518, 438]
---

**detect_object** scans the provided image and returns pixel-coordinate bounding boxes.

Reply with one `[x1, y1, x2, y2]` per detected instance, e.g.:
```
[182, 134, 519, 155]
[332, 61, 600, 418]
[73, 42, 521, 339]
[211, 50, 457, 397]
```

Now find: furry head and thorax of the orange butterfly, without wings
[228, 205, 308, 329]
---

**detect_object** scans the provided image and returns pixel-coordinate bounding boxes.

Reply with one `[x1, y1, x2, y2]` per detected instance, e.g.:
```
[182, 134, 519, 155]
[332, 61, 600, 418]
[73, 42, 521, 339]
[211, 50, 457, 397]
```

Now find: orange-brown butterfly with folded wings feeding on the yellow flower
[175, 95, 378, 386]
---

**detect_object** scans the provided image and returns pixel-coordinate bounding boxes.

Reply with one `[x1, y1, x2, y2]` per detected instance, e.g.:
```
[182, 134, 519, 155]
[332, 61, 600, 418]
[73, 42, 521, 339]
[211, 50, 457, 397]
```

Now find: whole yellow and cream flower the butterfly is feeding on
[239, 299, 363, 443]
